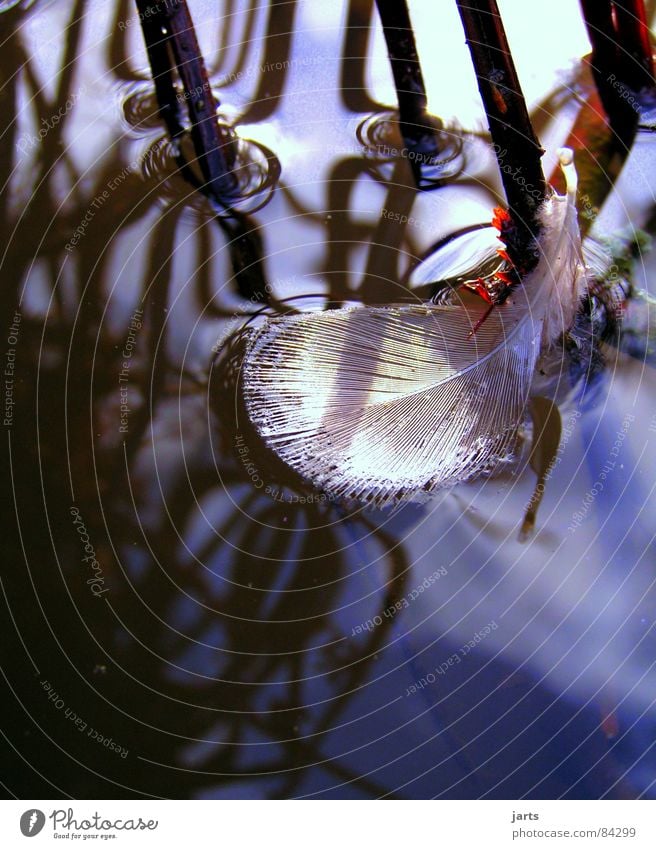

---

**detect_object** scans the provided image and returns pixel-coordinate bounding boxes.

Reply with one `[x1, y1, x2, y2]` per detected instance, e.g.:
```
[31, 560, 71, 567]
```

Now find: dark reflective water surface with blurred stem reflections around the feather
[0, 0, 656, 798]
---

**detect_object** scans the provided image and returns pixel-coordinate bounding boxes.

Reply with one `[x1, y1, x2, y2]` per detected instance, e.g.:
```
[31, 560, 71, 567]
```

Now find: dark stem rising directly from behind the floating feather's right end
[457, 0, 547, 268]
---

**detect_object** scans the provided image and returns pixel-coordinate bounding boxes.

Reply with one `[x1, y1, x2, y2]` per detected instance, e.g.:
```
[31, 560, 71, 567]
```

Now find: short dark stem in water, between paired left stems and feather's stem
[376, 0, 442, 161]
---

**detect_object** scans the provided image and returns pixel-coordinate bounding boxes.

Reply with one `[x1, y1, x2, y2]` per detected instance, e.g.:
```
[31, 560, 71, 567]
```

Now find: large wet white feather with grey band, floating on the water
[243, 151, 583, 506]
